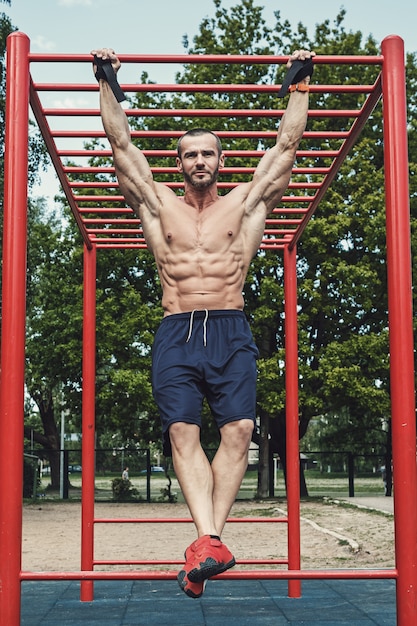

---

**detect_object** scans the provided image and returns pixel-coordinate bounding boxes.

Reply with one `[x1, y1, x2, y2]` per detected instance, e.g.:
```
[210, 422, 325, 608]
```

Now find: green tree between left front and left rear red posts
[25, 199, 82, 488]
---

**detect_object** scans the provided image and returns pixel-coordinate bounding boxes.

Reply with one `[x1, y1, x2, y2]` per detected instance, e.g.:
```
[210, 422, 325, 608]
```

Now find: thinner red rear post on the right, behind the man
[284, 246, 301, 598]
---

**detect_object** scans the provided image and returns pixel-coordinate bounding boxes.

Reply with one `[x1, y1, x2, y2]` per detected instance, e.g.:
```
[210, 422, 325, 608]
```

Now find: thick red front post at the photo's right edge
[382, 36, 417, 626]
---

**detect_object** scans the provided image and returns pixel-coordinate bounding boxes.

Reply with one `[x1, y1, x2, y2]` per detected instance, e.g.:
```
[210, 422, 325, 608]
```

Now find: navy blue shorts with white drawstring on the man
[152, 310, 258, 456]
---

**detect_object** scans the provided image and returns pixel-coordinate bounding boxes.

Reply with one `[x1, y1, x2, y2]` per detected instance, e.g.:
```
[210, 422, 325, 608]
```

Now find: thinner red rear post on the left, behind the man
[81, 245, 97, 602]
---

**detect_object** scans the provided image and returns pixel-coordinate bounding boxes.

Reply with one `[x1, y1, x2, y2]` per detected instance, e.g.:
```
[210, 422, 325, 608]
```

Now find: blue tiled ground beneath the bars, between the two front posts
[21, 580, 396, 626]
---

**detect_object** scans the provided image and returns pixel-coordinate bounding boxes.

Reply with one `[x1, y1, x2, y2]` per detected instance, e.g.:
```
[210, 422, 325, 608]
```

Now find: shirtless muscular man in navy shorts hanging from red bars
[92, 48, 314, 598]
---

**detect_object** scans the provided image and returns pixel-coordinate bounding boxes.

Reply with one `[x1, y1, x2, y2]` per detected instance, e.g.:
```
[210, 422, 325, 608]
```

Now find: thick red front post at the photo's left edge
[0, 33, 29, 626]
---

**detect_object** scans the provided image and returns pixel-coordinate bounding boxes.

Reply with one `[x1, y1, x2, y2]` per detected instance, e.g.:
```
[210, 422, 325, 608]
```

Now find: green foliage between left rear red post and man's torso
[93, 245, 162, 447]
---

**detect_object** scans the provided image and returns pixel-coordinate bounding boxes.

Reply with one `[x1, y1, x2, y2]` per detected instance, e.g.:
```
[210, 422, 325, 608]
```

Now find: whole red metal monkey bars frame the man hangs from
[0, 33, 417, 626]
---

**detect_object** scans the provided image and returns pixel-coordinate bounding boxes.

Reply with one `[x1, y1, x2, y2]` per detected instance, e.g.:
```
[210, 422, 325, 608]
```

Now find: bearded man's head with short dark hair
[177, 134, 224, 189]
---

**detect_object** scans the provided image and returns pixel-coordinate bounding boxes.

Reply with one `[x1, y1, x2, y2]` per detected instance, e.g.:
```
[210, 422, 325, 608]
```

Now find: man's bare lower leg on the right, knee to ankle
[211, 419, 254, 535]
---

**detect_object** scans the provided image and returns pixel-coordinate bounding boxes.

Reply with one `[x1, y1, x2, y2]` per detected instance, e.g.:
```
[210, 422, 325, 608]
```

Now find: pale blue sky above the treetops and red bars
[4, 0, 417, 197]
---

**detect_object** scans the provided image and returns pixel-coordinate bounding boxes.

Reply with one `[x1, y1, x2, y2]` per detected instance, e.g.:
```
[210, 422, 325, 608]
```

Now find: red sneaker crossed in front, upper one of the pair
[182, 535, 236, 583]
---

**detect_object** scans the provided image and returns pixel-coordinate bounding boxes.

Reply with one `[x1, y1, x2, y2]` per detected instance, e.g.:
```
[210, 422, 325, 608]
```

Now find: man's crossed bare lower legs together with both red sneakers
[170, 419, 253, 597]
